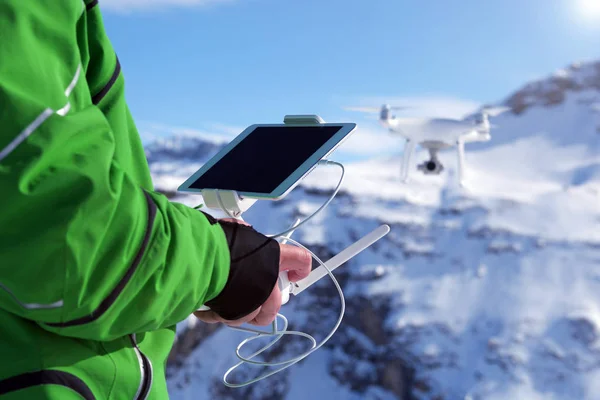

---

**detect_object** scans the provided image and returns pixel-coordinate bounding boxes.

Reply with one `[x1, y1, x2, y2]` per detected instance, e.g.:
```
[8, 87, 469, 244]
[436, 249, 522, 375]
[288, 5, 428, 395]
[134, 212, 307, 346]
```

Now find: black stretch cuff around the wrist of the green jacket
[206, 218, 280, 320]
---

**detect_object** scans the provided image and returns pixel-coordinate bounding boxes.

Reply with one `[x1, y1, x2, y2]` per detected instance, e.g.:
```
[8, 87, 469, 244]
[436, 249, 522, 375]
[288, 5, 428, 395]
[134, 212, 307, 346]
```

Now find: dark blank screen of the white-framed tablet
[190, 125, 343, 194]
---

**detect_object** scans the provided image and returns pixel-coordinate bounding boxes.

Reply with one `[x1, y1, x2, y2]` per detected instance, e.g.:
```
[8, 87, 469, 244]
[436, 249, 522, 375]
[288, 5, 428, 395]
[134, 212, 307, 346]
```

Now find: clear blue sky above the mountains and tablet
[100, 0, 600, 159]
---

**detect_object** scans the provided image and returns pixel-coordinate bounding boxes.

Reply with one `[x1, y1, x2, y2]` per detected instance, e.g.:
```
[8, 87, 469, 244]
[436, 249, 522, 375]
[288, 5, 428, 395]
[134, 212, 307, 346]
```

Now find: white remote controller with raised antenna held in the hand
[197, 225, 390, 311]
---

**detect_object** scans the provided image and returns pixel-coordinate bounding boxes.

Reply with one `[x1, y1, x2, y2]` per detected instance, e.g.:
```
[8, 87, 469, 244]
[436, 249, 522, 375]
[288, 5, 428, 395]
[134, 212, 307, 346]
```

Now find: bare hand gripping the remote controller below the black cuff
[194, 218, 312, 327]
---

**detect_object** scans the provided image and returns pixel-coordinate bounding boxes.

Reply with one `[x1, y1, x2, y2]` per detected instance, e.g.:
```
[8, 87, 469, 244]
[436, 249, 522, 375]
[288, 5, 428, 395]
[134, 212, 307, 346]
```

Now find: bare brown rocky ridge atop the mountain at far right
[504, 62, 600, 114]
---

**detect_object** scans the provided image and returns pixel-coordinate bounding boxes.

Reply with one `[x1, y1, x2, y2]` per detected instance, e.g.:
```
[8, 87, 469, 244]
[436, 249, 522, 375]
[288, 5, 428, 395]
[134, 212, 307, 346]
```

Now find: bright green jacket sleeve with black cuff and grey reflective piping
[0, 0, 279, 340]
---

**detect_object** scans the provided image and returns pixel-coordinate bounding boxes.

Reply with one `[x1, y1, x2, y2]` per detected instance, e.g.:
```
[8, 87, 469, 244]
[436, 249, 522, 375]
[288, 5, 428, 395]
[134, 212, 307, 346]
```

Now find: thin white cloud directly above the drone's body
[346, 95, 481, 118]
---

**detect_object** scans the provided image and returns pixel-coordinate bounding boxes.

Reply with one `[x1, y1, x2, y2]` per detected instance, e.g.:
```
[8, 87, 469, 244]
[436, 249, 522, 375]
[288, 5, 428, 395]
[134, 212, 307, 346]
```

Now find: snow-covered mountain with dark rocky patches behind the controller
[150, 62, 600, 400]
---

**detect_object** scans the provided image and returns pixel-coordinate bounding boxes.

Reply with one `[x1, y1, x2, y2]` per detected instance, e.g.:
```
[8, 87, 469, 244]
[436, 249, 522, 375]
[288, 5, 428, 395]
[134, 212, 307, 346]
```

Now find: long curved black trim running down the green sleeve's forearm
[45, 191, 156, 328]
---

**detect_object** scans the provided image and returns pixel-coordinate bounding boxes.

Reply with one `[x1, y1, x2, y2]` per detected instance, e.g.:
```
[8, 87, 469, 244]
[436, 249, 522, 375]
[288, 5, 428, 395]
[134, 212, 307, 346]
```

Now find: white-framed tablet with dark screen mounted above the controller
[178, 123, 356, 200]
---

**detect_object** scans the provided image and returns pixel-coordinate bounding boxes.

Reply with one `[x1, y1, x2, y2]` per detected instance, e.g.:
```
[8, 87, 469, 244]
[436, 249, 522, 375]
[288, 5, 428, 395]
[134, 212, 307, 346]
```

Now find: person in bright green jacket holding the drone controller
[0, 0, 311, 400]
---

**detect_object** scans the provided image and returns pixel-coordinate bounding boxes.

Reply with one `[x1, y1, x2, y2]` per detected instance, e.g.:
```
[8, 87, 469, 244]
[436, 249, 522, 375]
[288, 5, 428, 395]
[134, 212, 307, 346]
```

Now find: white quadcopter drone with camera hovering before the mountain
[346, 104, 508, 186]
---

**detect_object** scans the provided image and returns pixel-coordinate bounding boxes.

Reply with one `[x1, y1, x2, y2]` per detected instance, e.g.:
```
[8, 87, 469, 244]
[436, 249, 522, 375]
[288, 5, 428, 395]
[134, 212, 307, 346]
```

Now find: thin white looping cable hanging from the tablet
[216, 160, 346, 388]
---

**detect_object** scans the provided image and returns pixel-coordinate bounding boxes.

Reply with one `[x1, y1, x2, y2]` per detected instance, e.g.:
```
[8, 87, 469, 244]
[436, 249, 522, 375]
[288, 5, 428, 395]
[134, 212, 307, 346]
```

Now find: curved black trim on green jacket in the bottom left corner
[0, 370, 96, 400]
